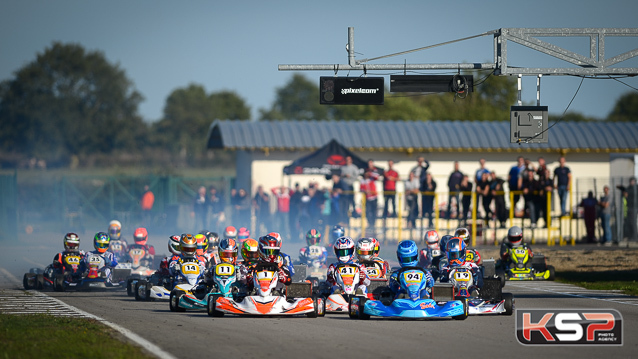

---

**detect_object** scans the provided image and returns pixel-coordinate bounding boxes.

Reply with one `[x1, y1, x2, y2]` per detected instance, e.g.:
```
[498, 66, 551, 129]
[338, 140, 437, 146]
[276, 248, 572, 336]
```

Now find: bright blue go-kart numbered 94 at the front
[348, 267, 468, 319]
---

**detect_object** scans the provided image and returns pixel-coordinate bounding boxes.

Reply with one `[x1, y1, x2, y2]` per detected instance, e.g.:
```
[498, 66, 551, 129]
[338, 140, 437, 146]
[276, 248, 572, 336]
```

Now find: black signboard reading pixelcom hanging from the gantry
[319, 77, 384, 105]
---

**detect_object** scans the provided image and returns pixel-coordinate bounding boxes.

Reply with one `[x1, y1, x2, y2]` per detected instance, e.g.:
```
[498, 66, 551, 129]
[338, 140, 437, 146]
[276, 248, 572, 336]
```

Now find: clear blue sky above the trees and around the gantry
[0, 0, 638, 122]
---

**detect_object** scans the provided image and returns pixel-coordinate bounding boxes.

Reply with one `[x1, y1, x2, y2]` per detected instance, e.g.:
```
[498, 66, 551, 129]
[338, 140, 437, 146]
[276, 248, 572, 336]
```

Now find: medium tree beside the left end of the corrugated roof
[153, 84, 250, 154]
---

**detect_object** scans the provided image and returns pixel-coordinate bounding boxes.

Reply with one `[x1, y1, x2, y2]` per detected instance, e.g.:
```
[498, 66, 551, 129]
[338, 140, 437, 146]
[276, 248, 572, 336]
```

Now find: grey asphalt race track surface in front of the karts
[0, 239, 638, 359]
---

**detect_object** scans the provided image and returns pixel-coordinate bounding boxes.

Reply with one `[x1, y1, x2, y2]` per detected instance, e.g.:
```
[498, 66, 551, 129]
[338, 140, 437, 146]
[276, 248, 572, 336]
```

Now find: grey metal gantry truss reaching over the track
[279, 27, 638, 77]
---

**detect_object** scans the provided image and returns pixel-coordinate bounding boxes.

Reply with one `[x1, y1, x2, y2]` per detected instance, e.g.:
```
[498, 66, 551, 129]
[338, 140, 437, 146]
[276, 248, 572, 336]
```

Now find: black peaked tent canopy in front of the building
[284, 139, 368, 176]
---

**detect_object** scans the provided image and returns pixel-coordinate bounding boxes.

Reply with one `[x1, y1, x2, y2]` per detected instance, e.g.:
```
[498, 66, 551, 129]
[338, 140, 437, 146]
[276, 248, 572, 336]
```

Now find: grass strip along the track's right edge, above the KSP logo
[556, 270, 638, 296]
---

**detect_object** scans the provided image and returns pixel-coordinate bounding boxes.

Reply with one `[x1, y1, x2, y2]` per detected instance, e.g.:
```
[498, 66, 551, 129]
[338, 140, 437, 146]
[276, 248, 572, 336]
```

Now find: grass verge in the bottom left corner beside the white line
[0, 313, 153, 359]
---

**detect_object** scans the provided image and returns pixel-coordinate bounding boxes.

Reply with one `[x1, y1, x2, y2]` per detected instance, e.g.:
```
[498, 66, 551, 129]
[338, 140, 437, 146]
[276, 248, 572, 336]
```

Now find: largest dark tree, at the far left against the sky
[0, 42, 146, 159]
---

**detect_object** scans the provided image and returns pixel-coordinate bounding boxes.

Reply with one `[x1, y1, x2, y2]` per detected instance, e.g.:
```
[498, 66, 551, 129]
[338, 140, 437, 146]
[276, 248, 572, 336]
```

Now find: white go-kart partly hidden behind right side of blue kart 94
[449, 267, 514, 315]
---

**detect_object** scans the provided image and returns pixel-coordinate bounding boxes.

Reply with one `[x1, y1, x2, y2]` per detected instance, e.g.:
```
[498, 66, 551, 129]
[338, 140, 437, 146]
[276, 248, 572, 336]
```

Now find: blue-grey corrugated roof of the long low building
[208, 120, 638, 152]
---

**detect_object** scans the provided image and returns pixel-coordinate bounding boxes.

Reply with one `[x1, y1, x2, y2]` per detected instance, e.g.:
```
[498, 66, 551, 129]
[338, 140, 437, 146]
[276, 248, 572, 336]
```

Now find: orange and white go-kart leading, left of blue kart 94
[207, 263, 325, 318]
